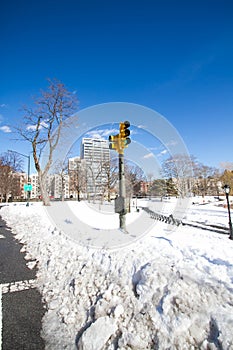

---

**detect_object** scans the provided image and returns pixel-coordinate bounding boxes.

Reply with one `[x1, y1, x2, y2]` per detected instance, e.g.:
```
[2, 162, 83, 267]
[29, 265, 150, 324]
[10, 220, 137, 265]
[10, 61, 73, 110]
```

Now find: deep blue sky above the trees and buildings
[0, 0, 233, 172]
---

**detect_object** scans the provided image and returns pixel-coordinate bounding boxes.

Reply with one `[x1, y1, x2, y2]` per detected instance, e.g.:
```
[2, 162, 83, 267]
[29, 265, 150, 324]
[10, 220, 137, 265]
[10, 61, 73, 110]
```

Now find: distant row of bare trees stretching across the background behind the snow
[0, 152, 233, 202]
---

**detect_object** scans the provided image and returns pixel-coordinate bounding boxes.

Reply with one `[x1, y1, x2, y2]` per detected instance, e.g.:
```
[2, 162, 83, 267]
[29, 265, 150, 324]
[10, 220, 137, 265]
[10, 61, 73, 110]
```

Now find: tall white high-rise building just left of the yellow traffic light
[80, 138, 110, 196]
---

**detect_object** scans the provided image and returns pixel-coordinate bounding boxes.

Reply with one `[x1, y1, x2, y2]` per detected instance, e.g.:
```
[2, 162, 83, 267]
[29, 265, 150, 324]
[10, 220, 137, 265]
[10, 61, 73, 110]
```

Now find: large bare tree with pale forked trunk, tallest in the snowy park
[17, 79, 77, 205]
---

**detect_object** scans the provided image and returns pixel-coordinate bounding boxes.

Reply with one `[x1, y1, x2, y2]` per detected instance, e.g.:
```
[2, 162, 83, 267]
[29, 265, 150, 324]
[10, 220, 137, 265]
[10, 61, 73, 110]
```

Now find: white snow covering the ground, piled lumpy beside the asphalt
[0, 199, 233, 350]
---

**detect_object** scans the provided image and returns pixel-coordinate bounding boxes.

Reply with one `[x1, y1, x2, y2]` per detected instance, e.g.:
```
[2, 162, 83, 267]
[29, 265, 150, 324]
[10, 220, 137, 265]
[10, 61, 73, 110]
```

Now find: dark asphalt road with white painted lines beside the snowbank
[0, 216, 45, 350]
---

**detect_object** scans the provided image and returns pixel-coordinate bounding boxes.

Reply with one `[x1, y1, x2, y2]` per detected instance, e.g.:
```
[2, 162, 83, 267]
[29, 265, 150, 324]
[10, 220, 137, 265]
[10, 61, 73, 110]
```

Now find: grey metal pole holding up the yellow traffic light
[119, 153, 126, 232]
